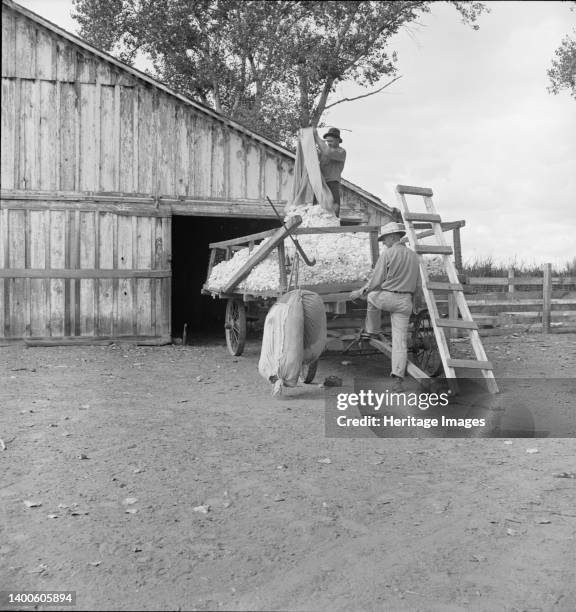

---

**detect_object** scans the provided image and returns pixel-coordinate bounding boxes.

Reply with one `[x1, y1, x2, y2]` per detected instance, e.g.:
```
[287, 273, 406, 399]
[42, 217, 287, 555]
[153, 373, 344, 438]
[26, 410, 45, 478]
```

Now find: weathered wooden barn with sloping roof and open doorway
[0, 0, 391, 343]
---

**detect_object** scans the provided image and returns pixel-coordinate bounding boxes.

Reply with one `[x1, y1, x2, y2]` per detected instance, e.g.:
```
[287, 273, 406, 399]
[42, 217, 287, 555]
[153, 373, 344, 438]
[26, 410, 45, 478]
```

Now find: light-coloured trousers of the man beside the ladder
[366, 291, 412, 378]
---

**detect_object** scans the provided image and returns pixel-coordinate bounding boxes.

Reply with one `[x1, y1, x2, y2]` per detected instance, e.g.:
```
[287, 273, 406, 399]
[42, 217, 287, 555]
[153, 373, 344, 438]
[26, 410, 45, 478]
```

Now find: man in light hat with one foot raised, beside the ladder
[350, 222, 420, 387]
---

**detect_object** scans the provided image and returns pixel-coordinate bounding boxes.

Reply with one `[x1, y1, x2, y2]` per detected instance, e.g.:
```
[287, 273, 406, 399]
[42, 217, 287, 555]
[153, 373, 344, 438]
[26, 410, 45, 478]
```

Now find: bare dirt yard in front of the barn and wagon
[0, 334, 576, 612]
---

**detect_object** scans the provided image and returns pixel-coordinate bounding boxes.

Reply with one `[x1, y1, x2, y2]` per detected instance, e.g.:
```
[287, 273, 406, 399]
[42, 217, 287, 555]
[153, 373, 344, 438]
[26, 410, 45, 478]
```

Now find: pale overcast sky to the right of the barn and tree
[19, 0, 576, 267]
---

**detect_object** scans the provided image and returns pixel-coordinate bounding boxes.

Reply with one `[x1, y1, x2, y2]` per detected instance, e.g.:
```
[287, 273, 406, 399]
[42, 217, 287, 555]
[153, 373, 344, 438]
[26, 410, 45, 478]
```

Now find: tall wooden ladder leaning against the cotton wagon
[396, 185, 498, 393]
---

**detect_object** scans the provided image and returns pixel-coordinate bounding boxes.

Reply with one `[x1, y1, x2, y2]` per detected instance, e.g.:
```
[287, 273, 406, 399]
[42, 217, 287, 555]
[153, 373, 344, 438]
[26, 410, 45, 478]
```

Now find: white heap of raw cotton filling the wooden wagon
[207, 204, 452, 292]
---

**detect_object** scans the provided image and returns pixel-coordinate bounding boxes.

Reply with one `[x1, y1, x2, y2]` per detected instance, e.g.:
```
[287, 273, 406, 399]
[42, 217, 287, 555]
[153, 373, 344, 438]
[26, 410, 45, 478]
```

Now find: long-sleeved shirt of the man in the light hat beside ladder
[366, 242, 420, 293]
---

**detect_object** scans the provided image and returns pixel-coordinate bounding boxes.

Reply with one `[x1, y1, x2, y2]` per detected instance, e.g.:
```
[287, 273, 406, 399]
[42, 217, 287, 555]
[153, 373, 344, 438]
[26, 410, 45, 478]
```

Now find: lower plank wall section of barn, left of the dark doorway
[0, 201, 171, 338]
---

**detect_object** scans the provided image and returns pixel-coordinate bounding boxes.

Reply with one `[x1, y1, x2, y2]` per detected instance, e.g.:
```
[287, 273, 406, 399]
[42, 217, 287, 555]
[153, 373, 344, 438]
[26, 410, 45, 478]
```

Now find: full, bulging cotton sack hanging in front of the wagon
[258, 290, 327, 395]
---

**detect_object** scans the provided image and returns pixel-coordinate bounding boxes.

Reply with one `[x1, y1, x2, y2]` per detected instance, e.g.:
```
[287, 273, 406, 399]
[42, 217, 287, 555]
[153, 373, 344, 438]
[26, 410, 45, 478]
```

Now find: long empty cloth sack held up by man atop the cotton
[291, 128, 335, 213]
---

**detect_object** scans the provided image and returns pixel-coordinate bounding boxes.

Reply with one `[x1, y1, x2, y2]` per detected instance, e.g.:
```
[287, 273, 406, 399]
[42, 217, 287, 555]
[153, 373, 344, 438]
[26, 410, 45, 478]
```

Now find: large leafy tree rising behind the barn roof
[73, 0, 488, 144]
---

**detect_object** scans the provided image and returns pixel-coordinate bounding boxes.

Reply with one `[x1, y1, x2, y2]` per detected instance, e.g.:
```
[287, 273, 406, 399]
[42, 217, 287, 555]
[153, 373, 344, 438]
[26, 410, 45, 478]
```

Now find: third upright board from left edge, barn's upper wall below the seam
[38, 81, 59, 191]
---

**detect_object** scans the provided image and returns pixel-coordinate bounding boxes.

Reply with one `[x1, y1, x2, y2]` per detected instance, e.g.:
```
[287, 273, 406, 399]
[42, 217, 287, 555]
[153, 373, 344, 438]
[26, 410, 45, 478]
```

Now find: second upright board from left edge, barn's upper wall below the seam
[19, 80, 40, 189]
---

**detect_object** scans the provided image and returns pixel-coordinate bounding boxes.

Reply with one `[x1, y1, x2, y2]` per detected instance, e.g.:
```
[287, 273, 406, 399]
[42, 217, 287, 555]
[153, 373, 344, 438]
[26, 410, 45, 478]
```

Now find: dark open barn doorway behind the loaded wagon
[172, 216, 280, 338]
